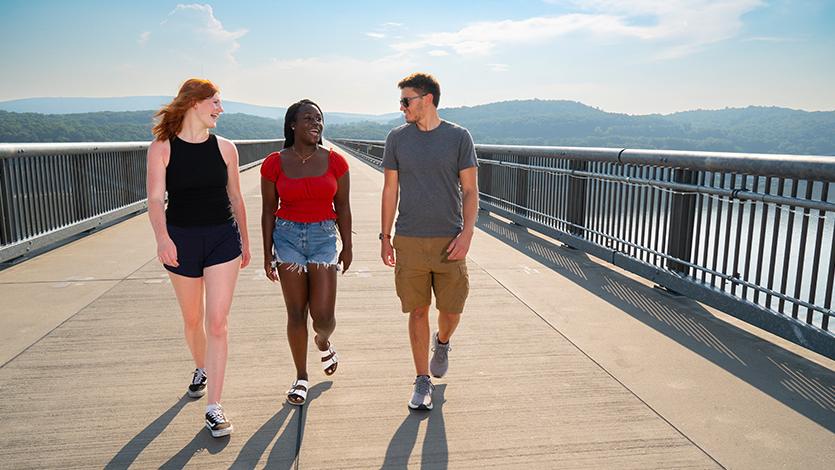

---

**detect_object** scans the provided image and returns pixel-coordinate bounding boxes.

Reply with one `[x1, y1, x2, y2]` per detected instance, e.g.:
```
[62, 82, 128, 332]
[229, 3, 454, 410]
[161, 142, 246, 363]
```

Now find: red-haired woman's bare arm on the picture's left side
[145, 140, 180, 267]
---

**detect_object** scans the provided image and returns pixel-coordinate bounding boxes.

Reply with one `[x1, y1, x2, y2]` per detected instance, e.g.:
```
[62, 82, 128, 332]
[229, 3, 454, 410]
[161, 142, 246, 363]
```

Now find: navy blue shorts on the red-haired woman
[163, 220, 242, 277]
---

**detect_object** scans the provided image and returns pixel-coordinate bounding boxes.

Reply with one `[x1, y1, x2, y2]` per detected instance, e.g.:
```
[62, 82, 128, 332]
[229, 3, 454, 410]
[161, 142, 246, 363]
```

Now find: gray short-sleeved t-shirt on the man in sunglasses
[383, 120, 478, 237]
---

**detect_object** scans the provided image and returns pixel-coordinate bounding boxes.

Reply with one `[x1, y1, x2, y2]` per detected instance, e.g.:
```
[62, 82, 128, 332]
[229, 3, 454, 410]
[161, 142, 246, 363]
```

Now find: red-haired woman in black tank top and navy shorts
[148, 78, 250, 437]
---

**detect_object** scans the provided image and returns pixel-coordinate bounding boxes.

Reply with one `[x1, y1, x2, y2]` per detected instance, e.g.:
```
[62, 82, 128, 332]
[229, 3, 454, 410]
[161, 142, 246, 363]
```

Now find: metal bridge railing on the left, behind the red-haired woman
[0, 140, 283, 262]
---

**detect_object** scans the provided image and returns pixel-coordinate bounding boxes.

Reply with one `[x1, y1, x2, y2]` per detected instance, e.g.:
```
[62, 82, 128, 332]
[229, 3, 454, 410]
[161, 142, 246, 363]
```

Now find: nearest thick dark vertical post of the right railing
[667, 168, 697, 276]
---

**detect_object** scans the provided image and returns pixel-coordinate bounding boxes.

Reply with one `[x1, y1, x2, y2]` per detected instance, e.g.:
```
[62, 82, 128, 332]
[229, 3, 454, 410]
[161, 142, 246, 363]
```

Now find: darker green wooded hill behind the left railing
[0, 111, 284, 143]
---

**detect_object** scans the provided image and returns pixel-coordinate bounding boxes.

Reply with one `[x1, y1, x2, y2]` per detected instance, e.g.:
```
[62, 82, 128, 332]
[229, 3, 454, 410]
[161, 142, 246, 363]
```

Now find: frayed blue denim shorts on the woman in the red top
[273, 218, 338, 272]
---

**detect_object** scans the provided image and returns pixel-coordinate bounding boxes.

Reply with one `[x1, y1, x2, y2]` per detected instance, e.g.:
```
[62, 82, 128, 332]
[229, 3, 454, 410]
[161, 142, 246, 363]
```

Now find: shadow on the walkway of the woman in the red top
[230, 381, 333, 469]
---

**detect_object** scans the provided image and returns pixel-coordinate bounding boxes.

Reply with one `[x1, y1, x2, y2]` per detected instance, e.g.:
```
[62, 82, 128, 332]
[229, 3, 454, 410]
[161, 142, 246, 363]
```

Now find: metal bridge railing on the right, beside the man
[335, 139, 835, 358]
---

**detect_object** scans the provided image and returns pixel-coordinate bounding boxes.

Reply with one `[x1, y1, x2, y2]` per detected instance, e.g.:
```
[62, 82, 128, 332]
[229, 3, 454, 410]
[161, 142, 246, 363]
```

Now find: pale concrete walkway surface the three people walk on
[0, 144, 835, 469]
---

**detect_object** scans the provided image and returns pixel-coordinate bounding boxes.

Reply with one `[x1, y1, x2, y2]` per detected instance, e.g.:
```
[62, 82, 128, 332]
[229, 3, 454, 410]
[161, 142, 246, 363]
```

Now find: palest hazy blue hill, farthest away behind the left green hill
[0, 96, 399, 124]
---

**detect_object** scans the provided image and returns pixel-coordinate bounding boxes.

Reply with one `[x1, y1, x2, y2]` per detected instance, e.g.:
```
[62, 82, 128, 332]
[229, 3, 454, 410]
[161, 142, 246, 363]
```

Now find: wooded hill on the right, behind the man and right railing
[327, 100, 835, 155]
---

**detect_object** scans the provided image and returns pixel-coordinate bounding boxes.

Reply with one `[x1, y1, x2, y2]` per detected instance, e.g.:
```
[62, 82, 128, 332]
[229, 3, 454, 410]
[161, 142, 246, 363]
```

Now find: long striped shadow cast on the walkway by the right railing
[477, 212, 835, 432]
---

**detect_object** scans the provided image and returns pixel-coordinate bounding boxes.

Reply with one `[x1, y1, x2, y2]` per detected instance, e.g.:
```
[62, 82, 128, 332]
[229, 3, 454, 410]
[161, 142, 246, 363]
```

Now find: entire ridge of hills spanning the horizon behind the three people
[0, 96, 835, 155]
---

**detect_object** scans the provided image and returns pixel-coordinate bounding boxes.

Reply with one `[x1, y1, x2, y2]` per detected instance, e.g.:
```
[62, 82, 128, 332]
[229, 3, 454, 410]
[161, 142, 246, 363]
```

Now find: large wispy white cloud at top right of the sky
[392, 0, 762, 58]
